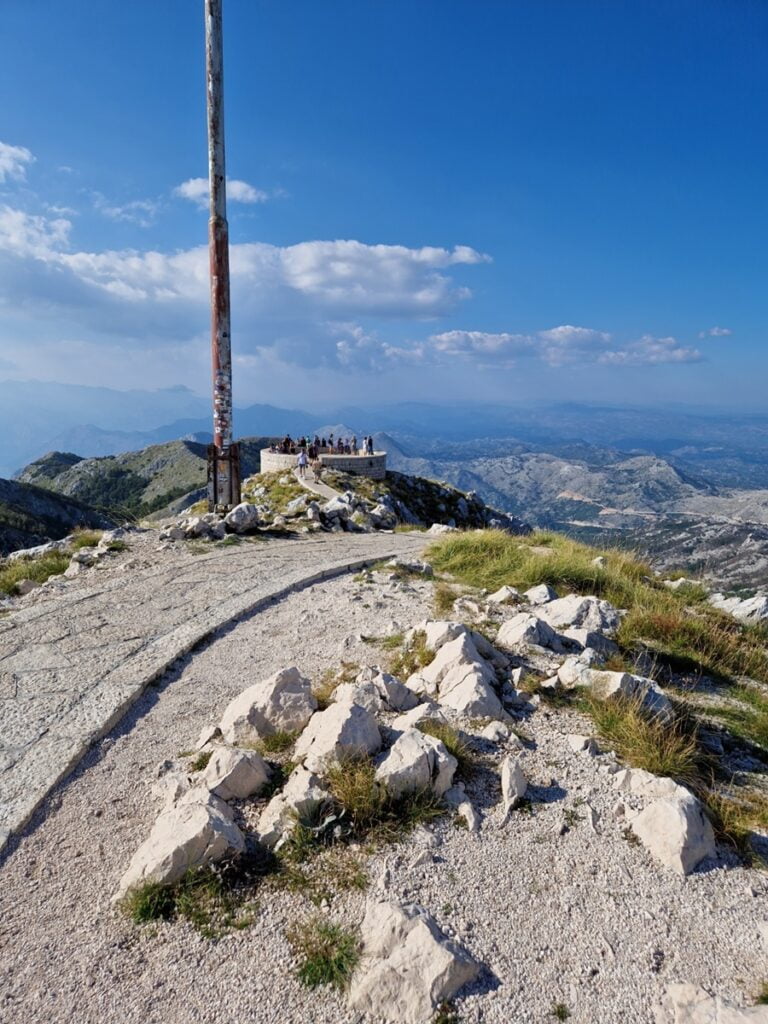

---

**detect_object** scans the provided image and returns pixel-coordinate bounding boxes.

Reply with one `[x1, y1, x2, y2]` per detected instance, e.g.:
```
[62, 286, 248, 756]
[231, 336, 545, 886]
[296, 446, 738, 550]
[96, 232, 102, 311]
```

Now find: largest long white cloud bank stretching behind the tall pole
[0, 200, 486, 369]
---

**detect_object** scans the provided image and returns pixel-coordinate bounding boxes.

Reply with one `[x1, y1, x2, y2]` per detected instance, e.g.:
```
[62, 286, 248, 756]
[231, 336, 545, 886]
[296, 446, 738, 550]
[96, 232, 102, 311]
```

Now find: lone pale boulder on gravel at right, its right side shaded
[631, 787, 717, 874]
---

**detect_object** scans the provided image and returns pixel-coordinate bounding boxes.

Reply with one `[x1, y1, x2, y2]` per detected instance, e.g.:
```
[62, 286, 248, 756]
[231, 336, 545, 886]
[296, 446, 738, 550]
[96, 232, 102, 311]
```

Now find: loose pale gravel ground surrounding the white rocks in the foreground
[0, 561, 768, 1024]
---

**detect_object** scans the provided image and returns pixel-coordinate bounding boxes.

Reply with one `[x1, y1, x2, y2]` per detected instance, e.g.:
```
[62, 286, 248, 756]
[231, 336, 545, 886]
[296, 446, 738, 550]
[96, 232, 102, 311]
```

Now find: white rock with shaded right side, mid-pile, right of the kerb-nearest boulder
[295, 703, 381, 772]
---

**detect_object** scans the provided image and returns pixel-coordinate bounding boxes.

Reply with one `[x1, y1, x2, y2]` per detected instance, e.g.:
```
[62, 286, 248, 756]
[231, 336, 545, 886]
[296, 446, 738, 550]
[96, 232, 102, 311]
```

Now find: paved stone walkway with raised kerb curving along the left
[0, 531, 424, 851]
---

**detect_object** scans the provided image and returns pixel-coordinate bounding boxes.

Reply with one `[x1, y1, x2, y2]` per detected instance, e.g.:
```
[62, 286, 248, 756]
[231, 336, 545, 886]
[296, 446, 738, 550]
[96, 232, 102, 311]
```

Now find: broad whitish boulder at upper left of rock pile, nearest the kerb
[220, 668, 317, 744]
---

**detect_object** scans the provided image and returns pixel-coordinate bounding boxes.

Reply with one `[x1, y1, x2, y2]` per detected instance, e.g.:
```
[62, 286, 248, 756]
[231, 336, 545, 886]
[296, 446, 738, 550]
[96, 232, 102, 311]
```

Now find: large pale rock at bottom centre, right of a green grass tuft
[349, 902, 480, 1024]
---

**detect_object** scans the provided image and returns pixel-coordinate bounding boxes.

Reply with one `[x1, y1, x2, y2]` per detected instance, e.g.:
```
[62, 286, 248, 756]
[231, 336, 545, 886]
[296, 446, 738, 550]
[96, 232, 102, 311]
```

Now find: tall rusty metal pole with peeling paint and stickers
[205, 0, 240, 511]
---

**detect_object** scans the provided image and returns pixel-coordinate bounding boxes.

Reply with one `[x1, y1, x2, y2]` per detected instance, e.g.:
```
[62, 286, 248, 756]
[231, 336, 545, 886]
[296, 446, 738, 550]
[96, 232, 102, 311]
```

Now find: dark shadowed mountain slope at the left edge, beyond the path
[0, 479, 114, 555]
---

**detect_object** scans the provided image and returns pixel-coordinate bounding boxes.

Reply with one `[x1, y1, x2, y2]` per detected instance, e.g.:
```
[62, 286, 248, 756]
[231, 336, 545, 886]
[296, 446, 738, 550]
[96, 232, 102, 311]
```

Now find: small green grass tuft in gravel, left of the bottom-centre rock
[287, 916, 360, 989]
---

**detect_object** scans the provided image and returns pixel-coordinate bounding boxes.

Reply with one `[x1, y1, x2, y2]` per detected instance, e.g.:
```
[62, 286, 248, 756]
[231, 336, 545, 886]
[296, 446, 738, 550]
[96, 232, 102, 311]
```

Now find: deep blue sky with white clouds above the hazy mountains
[0, 0, 768, 409]
